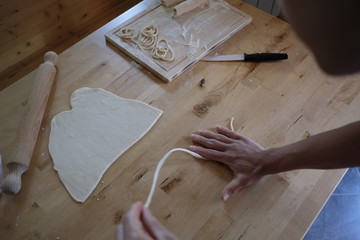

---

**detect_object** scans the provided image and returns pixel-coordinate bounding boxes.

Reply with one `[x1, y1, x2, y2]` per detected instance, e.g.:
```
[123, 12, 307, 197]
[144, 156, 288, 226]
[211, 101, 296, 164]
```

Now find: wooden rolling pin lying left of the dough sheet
[1, 52, 57, 194]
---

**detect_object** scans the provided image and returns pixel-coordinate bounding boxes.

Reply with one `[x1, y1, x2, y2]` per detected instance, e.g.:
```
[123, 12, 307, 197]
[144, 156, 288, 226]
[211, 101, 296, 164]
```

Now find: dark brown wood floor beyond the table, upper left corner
[0, 0, 141, 90]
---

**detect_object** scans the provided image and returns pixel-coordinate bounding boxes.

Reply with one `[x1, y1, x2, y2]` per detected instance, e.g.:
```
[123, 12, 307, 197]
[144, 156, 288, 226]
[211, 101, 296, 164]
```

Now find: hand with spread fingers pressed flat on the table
[190, 126, 266, 201]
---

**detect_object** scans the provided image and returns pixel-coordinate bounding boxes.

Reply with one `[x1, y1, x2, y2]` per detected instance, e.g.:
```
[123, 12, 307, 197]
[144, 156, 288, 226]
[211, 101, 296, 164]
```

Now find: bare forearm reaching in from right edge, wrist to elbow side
[263, 121, 360, 174]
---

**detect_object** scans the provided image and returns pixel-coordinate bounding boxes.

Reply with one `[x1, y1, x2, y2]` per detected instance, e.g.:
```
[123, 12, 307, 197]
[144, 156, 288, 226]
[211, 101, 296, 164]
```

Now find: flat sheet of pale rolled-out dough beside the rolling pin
[49, 88, 162, 202]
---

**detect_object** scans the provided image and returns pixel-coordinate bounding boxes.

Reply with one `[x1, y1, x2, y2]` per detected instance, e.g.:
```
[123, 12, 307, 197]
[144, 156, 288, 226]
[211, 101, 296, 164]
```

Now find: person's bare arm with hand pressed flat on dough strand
[190, 121, 360, 200]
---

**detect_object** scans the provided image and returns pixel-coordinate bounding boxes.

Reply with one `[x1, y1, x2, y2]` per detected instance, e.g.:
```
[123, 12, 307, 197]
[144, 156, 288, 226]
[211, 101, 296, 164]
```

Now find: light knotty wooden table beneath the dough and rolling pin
[0, 0, 360, 239]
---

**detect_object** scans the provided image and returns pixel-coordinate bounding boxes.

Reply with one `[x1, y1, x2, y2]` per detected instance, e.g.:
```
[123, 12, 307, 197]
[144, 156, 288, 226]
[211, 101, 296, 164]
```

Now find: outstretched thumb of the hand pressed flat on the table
[222, 173, 259, 201]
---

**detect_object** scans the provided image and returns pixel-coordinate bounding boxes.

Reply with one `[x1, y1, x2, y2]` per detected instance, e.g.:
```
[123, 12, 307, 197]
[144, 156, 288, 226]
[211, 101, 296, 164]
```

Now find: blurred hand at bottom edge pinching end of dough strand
[116, 202, 177, 240]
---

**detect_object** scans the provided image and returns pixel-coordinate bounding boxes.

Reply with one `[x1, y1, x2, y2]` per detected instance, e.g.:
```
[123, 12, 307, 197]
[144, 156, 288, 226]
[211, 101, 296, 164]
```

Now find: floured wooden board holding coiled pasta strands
[105, 0, 251, 82]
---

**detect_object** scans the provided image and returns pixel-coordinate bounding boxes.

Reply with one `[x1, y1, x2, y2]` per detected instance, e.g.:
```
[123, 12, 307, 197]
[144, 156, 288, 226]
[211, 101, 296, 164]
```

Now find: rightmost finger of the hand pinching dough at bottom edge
[142, 208, 177, 240]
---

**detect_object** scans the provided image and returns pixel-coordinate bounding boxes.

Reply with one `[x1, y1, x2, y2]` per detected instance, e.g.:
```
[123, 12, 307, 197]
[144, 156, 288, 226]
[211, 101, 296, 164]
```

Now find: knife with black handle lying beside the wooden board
[201, 53, 288, 62]
